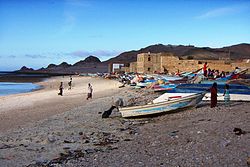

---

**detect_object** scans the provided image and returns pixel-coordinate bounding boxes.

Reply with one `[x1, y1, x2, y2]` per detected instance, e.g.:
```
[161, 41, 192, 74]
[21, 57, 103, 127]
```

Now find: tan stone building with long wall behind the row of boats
[127, 53, 250, 74]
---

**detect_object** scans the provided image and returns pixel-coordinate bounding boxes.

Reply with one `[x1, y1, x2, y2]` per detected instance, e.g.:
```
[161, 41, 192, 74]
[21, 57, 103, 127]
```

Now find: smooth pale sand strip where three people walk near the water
[0, 77, 119, 132]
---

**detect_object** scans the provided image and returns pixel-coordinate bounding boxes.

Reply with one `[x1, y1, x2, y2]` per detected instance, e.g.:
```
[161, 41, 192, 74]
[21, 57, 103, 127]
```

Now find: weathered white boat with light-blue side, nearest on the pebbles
[120, 92, 205, 117]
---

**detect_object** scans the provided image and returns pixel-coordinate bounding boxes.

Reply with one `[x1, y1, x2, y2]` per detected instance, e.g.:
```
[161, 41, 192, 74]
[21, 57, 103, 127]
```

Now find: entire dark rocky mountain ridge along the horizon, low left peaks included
[19, 43, 250, 73]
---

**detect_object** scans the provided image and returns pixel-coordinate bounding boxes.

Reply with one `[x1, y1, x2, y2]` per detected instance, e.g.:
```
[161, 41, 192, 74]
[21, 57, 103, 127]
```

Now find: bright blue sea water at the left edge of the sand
[0, 71, 41, 96]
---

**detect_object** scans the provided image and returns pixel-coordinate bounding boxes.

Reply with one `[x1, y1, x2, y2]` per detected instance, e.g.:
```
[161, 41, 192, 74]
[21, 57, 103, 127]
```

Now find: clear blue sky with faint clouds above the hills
[0, 0, 250, 71]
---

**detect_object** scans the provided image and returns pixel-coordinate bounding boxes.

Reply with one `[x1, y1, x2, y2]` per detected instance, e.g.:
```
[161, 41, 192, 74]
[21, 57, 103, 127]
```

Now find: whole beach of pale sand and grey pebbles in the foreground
[0, 77, 250, 167]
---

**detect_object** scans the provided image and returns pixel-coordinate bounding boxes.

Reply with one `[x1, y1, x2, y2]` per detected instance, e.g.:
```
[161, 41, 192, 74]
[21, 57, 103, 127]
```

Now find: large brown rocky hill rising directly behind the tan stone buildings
[105, 43, 250, 63]
